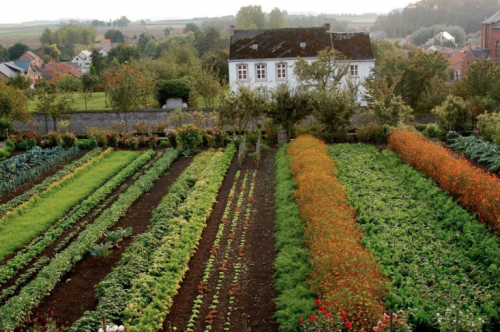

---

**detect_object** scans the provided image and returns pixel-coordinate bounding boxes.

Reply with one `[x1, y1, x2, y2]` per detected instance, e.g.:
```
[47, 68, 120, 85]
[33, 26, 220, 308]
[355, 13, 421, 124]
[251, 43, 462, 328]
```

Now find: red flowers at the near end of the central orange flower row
[299, 300, 352, 332]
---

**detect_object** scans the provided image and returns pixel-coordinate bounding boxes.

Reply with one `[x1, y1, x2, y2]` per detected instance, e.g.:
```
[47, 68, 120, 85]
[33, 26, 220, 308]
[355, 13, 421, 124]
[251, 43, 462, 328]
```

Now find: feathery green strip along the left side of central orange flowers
[274, 146, 315, 331]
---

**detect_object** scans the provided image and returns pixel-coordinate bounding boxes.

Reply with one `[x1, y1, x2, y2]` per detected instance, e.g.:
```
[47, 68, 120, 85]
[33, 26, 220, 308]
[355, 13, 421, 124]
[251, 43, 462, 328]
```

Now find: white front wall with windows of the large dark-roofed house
[229, 58, 375, 106]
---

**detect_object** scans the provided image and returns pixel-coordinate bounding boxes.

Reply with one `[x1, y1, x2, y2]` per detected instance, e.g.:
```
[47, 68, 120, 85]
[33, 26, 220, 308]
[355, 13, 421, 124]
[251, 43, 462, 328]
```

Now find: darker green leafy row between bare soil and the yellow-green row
[71, 152, 215, 331]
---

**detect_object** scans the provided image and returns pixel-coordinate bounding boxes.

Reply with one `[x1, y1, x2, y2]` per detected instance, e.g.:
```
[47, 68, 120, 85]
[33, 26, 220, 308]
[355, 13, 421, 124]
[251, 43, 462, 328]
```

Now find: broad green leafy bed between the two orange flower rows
[331, 145, 500, 332]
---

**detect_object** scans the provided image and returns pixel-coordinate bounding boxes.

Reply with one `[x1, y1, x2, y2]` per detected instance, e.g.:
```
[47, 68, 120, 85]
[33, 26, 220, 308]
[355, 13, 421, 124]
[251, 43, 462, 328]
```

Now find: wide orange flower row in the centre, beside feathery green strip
[287, 136, 388, 331]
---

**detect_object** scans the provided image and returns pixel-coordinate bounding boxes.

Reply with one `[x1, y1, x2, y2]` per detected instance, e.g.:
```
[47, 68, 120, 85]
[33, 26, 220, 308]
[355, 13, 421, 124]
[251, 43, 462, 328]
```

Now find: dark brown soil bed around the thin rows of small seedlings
[164, 149, 278, 332]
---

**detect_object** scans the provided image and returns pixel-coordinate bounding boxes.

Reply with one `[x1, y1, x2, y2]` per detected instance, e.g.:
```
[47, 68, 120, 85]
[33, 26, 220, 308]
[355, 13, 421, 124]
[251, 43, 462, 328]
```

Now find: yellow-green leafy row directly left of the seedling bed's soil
[123, 144, 236, 332]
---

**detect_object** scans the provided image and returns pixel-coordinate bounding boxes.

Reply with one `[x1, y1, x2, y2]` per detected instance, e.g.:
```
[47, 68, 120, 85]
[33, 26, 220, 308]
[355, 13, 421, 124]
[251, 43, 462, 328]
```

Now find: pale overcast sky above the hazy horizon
[0, 0, 416, 24]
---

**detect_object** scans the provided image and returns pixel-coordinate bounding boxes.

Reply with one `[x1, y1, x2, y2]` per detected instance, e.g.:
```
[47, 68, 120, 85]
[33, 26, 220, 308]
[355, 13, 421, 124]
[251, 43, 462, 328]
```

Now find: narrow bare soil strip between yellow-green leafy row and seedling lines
[163, 157, 240, 332]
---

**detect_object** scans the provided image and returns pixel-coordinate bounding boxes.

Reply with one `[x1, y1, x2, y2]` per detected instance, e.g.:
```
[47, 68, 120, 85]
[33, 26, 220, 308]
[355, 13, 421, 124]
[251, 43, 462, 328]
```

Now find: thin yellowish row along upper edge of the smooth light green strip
[0, 148, 113, 225]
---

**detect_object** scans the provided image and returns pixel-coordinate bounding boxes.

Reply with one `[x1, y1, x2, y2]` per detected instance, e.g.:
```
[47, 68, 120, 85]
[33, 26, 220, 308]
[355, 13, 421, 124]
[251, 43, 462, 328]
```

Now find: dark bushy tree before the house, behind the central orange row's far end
[264, 83, 313, 137]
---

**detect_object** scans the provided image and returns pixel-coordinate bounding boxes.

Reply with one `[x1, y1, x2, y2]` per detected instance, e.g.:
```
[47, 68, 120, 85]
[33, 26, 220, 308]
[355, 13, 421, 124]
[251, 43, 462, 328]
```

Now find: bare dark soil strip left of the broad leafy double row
[24, 158, 193, 326]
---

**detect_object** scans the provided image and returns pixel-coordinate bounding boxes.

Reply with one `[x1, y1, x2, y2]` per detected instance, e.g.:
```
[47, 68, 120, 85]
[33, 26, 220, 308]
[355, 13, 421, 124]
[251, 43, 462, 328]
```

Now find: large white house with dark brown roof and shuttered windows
[229, 24, 375, 104]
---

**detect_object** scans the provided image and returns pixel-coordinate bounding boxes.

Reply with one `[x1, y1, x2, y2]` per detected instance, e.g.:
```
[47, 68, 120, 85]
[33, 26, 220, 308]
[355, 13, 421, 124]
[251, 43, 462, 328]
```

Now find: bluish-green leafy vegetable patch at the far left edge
[0, 146, 79, 196]
